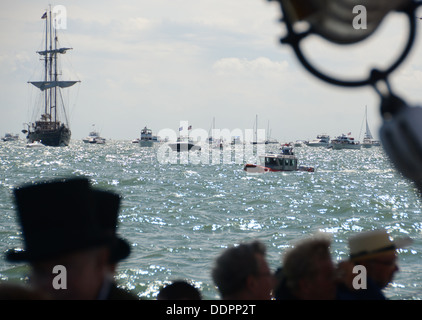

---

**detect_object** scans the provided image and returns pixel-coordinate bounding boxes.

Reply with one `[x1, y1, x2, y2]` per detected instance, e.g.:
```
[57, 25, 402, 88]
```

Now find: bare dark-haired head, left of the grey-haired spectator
[212, 241, 274, 300]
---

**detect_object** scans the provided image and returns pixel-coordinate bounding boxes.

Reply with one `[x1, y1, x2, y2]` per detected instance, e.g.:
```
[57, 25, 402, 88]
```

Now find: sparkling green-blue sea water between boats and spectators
[0, 140, 422, 300]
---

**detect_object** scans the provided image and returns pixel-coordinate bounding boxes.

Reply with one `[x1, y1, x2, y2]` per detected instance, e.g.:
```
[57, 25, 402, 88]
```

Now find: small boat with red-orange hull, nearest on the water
[243, 144, 315, 173]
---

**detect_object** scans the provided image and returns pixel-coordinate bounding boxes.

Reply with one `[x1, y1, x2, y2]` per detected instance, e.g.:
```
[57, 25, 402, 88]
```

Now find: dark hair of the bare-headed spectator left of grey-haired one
[212, 241, 266, 297]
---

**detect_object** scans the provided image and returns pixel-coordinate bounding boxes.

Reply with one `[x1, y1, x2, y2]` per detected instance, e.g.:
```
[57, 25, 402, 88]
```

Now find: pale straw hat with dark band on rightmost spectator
[349, 230, 413, 260]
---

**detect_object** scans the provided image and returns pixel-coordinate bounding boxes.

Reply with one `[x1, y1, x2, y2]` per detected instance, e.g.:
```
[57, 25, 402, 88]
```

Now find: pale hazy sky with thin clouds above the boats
[0, 0, 422, 142]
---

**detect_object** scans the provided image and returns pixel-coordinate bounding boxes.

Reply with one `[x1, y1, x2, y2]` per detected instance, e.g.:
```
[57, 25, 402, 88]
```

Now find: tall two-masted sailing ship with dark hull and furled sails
[22, 6, 80, 146]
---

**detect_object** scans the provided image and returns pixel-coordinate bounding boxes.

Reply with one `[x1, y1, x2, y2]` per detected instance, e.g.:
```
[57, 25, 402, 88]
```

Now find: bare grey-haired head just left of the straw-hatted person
[282, 235, 336, 300]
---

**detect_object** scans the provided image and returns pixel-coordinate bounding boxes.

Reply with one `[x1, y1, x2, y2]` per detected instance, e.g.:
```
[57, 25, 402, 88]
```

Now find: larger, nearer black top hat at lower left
[6, 178, 129, 262]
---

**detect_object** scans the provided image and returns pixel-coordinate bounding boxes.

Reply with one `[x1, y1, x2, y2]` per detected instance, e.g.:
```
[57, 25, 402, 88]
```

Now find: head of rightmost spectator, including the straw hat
[349, 230, 411, 288]
